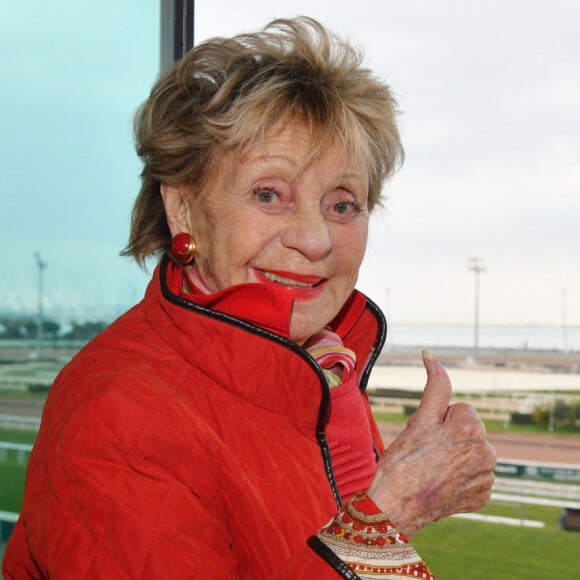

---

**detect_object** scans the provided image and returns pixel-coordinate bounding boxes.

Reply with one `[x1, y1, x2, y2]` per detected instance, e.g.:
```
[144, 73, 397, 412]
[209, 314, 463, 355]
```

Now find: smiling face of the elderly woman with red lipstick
[164, 121, 368, 343]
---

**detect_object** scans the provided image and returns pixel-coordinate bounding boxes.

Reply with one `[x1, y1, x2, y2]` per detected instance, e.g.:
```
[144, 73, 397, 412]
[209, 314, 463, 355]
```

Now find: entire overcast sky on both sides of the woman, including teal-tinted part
[0, 0, 580, 336]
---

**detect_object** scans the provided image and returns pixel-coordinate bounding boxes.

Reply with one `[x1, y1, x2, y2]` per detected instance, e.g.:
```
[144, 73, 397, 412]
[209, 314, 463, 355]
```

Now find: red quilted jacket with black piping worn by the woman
[3, 264, 384, 580]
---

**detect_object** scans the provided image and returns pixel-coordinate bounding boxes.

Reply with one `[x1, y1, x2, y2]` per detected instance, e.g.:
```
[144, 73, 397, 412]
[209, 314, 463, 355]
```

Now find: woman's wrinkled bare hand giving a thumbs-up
[367, 351, 496, 538]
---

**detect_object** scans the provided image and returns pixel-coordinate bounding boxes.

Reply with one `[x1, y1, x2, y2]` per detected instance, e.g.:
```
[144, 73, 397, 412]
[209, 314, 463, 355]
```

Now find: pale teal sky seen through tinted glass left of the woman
[0, 0, 160, 323]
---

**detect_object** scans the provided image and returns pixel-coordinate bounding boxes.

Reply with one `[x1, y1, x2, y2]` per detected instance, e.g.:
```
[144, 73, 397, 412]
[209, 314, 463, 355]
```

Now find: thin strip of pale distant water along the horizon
[387, 322, 580, 351]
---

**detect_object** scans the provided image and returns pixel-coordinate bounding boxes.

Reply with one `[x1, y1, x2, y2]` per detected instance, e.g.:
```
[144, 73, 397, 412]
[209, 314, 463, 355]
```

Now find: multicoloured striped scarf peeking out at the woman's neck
[184, 266, 356, 389]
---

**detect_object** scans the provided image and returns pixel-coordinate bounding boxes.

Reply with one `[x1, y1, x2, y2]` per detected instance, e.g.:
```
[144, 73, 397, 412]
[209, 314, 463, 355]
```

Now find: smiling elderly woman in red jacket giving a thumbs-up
[4, 18, 495, 579]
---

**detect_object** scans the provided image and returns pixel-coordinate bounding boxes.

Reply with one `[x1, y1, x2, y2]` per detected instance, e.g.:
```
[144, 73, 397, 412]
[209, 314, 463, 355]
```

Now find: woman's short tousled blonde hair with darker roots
[122, 17, 404, 264]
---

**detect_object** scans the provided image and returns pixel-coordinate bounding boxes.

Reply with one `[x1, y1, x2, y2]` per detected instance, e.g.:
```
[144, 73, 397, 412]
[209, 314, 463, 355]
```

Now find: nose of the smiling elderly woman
[281, 207, 333, 262]
